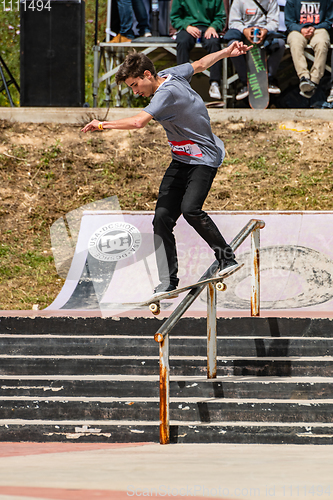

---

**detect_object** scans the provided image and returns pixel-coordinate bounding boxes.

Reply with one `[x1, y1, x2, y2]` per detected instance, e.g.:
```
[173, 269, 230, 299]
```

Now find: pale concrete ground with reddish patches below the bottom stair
[0, 443, 333, 500]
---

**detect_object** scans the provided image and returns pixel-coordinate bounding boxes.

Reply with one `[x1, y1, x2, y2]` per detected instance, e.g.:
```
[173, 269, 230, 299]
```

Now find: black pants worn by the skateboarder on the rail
[153, 160, 233, 286]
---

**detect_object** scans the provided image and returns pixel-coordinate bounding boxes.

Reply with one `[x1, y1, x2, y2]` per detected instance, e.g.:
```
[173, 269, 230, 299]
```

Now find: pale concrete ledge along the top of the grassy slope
[0, 107, 333, 125]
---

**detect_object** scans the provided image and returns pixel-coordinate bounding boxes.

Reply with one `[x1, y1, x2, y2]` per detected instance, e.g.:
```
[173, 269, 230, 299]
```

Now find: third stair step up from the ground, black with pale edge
[0, 375, 333, 400]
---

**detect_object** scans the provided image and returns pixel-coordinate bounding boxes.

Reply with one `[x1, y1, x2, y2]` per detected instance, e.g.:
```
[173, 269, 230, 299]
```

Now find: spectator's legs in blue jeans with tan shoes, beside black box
[111, 0, 151, 43]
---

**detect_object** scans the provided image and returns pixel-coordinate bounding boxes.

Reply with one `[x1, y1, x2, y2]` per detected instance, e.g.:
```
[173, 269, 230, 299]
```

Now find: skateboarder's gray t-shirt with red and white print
[144, 63, 225, 168]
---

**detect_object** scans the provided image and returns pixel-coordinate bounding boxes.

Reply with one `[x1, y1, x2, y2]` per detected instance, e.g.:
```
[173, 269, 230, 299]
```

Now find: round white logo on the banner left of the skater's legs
[88, 222, 142, 262]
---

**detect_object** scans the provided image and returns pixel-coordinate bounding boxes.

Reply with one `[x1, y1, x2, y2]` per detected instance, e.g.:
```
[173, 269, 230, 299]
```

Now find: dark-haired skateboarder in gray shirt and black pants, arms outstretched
[82, 41, 250, 293]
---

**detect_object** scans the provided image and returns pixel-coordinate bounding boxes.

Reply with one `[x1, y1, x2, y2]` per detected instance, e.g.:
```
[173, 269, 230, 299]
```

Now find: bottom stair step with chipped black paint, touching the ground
[0, 420, 333, 445]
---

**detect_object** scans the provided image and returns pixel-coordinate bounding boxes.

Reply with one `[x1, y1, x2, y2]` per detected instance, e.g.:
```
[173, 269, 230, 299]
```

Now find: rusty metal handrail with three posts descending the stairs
[154, 219, 265, 444]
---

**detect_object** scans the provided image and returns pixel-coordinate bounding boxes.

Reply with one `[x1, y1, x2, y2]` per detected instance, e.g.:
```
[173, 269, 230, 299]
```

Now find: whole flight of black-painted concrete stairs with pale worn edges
[0, 317, 333, 444]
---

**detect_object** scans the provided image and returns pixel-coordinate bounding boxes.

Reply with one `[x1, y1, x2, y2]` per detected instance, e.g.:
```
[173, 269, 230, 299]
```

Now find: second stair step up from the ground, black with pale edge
[0, 396, 333, 423]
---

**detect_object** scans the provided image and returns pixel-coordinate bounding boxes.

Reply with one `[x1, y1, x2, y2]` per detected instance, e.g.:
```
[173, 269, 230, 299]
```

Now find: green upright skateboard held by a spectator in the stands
[246, 44, 269, 109]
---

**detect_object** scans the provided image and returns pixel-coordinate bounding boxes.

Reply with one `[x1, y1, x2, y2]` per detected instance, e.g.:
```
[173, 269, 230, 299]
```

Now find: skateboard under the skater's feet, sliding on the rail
[133, 264, 244, 316]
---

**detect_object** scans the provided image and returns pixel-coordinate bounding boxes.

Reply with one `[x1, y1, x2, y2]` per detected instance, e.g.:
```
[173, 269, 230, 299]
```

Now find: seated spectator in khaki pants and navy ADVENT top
[284, 0, 333, 99]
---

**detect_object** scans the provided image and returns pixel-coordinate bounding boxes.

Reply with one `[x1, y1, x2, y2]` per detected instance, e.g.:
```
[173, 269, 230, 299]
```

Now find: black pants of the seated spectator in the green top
[176, 26, 222, 84]
